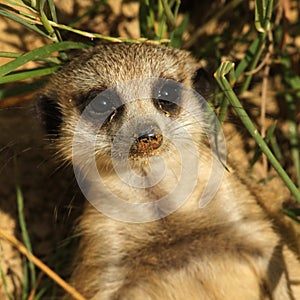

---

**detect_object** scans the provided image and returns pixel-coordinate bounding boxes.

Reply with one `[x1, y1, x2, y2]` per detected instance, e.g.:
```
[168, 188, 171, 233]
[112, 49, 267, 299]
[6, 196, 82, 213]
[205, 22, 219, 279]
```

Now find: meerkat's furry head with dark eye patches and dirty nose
[38, 43, 223, 218]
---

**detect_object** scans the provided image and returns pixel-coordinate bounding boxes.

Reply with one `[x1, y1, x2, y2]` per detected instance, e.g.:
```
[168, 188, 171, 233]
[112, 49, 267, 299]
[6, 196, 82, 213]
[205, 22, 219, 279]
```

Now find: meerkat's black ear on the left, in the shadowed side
[35, 94, 62, 136]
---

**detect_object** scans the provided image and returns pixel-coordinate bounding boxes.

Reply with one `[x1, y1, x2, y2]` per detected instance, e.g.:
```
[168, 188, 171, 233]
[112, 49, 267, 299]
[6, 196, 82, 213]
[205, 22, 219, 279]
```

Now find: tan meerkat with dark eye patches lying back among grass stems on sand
[38, 43, 300, 300]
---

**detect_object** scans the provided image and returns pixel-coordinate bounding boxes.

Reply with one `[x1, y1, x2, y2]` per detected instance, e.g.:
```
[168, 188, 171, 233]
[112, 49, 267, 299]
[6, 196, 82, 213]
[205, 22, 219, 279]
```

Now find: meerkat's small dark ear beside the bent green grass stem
[192, 67, 215, 99]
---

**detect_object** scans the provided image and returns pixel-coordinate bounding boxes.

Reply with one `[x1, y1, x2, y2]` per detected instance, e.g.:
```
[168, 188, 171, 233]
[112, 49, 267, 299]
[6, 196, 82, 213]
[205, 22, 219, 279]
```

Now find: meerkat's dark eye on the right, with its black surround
[154, 82, 180, 116]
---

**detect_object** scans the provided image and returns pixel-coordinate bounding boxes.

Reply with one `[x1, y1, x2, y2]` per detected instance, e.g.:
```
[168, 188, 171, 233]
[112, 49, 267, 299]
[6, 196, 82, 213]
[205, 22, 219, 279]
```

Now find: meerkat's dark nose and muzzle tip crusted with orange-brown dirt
[130, 123, 163, 157]
